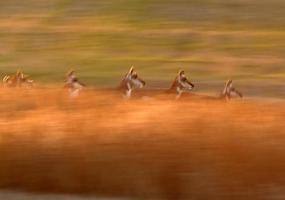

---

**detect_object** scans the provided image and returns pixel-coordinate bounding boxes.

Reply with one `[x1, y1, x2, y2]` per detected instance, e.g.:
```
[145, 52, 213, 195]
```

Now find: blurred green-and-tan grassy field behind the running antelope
[0, 0, 285, 94]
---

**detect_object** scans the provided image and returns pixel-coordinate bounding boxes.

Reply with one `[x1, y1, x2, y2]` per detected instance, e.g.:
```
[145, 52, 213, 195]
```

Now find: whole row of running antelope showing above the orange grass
[3, 67, 243, 100]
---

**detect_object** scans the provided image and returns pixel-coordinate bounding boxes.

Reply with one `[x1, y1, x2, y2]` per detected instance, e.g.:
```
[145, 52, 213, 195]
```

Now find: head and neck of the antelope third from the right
[119, 67, 145, 98]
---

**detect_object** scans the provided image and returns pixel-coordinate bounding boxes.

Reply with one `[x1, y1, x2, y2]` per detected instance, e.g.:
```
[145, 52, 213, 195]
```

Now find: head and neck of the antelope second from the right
[169, 70, 194, 98]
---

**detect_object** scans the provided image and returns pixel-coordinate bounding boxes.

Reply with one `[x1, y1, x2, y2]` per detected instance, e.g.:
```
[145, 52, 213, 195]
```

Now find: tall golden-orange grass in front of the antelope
[0, 88, 285, 199]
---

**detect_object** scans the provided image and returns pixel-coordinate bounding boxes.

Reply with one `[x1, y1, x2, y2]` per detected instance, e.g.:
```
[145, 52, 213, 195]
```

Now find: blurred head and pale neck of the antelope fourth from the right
[64, 70, 85, 97]
